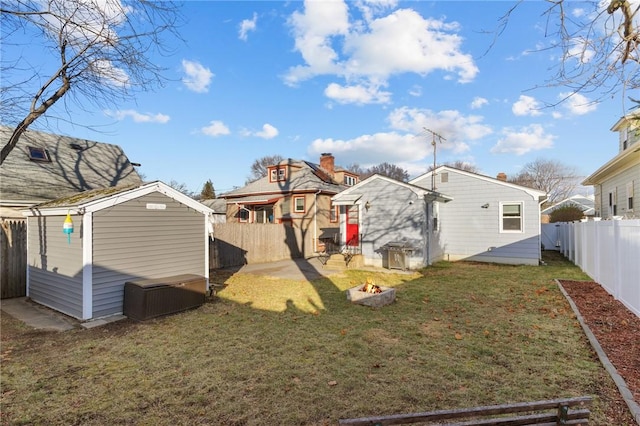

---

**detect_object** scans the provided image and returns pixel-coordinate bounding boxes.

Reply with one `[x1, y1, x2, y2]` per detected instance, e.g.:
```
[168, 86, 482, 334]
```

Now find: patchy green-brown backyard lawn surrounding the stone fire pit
[1, 253, 632, 425]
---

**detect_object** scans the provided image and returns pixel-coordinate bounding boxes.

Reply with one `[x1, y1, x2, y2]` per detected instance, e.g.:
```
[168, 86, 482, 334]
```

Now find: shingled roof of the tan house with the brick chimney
[220, 160, 348, 202]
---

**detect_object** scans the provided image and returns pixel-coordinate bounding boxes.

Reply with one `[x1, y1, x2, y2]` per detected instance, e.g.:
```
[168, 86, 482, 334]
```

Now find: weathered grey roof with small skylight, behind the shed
[0, 126, 142, 207]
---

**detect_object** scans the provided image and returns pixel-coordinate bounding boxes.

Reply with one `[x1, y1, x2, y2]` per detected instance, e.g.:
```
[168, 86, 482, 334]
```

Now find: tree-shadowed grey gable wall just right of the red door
[358, 180, 426, 268]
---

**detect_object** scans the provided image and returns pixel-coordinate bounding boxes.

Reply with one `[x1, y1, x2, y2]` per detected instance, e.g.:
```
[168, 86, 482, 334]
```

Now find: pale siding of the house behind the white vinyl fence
[594, 165, 640, 219]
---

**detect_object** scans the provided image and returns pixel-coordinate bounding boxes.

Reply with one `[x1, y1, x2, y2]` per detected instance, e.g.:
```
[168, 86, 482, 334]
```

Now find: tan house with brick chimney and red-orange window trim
[219, 153, 359, 257]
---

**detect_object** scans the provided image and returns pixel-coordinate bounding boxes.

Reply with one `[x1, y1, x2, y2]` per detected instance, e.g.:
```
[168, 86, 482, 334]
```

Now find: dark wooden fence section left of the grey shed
[0, 219, 27, 299]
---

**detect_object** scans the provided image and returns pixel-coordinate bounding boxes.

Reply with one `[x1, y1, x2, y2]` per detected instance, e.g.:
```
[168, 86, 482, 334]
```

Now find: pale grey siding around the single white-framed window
[411, 170, 540, 265]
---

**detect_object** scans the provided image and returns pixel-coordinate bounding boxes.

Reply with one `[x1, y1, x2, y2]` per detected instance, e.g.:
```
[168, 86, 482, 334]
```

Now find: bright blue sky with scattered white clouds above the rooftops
[3, 0, 629, 194]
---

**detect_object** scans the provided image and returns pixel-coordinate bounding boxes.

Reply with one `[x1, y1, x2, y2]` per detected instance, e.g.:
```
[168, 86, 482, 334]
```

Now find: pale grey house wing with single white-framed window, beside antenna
[409, 166, 547, 265]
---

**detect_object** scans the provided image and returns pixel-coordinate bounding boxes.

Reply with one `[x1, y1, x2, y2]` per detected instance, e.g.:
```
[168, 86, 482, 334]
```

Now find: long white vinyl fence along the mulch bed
[543, 219, 640, 317]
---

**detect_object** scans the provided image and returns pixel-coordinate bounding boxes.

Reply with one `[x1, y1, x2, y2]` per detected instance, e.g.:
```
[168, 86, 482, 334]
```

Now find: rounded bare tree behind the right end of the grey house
[509, 159, 580, 207]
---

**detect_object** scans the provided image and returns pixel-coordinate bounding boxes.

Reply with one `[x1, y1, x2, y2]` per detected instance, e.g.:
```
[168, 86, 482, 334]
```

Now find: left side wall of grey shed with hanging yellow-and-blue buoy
[27, 216, 83, 318]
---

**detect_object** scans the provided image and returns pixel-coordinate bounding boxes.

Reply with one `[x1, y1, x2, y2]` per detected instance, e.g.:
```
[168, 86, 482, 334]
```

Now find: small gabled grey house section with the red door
[332, 174, 451, 269]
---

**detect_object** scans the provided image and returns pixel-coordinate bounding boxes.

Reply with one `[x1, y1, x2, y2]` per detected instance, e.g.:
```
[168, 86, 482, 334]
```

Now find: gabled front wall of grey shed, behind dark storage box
[93, 192, 205, 318]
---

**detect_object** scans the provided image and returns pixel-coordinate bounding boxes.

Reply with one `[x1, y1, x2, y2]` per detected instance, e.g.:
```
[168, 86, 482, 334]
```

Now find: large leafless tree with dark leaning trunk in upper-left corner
[0, 0, 179, 164]
